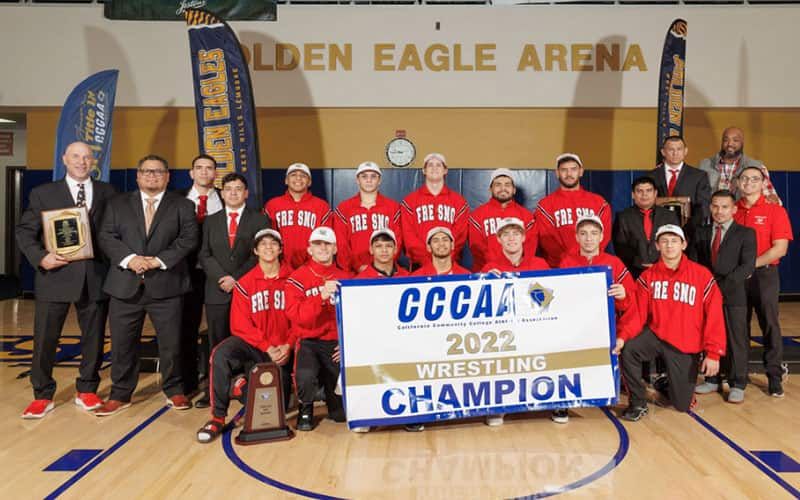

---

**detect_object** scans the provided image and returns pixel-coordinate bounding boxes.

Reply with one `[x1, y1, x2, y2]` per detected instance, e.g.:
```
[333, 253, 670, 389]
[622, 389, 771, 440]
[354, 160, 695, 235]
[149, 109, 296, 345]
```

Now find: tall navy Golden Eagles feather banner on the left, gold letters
[185, 9, 262, 209]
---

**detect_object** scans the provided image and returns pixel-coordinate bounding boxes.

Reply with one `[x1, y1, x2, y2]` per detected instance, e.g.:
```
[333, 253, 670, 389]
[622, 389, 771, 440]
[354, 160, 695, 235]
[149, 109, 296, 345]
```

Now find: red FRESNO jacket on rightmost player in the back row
[536, 189, 611, 267]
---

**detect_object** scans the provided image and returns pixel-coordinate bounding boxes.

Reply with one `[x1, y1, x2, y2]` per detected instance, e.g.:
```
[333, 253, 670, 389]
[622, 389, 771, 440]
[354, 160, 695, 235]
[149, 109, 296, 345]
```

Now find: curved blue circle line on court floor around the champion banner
[222, 408, 630, 500]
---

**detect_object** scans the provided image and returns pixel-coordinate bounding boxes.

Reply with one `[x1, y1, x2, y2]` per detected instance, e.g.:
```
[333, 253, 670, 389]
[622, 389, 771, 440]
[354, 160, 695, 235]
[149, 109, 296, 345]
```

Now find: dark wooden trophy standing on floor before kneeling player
[236, 363, 294, 445]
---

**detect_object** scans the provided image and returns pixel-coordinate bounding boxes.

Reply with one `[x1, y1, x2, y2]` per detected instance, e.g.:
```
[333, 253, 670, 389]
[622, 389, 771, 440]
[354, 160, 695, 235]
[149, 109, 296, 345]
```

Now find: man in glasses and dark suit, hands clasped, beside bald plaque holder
[95, 155, 198, 416]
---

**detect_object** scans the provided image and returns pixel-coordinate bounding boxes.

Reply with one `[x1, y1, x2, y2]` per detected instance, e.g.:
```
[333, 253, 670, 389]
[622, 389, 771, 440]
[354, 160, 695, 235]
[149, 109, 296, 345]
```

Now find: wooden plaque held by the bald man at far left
[42, 207, 94, 261]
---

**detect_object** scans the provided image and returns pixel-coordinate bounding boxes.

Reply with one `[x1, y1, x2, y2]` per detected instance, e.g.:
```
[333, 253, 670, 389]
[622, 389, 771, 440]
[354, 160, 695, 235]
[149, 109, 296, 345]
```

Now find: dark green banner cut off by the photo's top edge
[103, 0, 277, 21]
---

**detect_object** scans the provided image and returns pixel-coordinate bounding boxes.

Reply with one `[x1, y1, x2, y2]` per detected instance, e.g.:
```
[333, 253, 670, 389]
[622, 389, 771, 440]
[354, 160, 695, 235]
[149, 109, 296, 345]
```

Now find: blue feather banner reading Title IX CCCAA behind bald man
[53, 69, 119, 182]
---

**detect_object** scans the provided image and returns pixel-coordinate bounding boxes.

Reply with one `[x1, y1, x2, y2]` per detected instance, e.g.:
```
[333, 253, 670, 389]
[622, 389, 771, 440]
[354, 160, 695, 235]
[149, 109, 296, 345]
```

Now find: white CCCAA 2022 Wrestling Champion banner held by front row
[337, 267, 619, 428]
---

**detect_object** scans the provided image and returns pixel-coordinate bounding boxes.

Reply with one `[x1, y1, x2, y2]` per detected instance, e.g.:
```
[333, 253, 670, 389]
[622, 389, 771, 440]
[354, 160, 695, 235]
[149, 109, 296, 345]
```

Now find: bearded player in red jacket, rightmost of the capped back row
[535, 153, 611, 267]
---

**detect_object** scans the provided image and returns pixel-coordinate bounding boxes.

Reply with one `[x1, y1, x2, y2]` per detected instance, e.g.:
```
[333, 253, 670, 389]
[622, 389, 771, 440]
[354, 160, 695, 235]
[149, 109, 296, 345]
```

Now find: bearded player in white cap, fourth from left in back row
[469, 168, 536, 272]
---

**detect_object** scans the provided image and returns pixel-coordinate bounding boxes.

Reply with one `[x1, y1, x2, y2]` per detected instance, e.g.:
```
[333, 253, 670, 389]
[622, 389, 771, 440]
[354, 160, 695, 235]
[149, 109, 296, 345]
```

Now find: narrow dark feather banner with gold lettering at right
[656, 19, 687, 163]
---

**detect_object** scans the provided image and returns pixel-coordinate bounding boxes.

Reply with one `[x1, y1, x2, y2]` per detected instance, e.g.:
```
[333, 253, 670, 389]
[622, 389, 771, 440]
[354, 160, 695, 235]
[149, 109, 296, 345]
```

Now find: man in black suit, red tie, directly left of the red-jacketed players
[196, 174, 270, 408]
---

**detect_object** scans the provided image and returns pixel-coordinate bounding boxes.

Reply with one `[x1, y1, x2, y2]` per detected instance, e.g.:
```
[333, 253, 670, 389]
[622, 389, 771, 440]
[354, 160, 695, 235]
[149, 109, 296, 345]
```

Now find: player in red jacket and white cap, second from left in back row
[333, 161, 400, 273]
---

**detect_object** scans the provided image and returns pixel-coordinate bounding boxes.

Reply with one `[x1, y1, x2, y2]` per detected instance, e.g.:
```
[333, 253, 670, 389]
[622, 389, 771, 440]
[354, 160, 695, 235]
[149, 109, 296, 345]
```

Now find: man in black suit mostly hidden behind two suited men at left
[177, 154, 224, 400]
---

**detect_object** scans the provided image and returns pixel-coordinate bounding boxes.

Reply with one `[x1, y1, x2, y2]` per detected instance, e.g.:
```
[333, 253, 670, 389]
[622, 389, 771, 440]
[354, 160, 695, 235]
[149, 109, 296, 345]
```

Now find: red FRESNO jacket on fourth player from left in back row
[469, 198, 537, 272]
